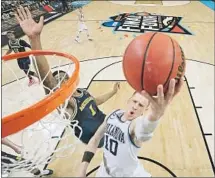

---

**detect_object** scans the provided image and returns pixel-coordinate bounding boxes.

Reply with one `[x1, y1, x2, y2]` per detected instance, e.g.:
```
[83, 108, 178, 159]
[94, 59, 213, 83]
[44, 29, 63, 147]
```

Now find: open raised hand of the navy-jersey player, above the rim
[15, 6, 44, 38]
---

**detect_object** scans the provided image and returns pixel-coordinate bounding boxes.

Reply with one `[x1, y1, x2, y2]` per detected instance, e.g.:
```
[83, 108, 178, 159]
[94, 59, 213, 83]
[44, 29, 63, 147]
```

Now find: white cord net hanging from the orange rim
[1, 52, 82, 176]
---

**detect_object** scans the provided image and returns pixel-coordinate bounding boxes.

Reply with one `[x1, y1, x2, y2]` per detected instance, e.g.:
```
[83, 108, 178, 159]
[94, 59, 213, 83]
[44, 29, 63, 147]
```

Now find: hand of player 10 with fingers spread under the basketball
[141, 78, 183, 120]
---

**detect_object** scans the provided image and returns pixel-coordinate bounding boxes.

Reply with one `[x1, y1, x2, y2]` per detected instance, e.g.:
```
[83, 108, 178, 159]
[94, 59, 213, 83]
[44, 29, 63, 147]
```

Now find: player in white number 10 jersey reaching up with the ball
[79, 79, 183, 177]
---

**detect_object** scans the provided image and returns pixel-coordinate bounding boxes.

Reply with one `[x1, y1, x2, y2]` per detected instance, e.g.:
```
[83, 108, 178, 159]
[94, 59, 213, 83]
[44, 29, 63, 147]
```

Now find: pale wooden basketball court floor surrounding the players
[2, 1, 215, 177]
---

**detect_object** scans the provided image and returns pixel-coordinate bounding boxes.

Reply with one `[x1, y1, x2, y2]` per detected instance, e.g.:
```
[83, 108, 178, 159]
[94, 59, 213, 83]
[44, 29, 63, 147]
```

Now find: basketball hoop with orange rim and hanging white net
[2, 50, 82, 177]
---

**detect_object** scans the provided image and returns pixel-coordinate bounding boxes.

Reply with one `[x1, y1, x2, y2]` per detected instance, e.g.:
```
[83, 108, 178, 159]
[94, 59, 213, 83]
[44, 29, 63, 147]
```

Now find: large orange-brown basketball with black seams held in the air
[122, 32, 185, 95]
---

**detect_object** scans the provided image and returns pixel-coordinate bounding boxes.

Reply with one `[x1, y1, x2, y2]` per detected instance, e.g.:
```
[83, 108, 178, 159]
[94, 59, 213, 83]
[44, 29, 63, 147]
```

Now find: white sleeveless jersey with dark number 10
[97, 110, 150, 177]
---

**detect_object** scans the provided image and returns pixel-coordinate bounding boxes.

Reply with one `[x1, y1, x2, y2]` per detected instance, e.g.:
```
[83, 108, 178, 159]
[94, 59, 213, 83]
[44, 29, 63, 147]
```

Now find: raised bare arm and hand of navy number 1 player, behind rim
[15, 6, 57, 94]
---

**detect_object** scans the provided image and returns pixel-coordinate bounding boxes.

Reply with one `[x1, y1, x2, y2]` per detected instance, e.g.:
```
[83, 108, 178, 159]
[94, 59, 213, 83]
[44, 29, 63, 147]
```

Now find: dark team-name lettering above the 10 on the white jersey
[106, 124, 125, 143]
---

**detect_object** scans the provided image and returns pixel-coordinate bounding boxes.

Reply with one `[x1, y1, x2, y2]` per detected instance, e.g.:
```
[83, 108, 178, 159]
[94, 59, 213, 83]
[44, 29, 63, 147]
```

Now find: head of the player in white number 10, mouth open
[126, 92, 150, 120]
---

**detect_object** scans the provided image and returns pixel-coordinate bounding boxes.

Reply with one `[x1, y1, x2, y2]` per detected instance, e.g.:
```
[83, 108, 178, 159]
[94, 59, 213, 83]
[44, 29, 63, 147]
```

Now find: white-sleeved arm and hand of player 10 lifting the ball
[130, 78, 183, 146]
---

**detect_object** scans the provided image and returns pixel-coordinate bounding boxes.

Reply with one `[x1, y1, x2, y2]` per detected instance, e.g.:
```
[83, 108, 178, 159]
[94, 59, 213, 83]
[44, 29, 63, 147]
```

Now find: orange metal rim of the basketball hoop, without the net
[2, 50, 80, 138]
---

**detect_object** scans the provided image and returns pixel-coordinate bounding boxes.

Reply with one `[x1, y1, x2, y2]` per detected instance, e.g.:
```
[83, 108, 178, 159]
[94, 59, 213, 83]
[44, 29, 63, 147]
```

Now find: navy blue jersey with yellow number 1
[73, 89, 105, 147]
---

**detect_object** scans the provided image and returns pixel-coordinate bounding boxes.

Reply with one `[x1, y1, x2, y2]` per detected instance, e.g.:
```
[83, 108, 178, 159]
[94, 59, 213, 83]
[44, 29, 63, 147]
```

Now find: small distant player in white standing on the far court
[75, 7, 92, 43]
